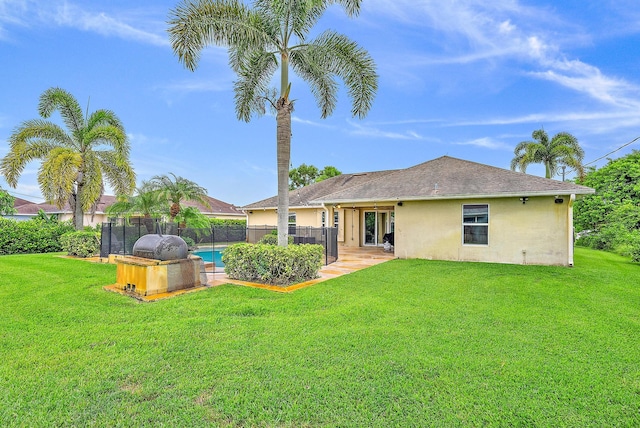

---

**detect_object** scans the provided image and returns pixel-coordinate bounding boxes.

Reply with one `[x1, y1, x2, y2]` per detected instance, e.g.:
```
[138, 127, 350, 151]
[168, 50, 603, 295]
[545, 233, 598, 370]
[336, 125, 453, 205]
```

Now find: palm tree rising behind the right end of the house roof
[511, 129, 584, 178]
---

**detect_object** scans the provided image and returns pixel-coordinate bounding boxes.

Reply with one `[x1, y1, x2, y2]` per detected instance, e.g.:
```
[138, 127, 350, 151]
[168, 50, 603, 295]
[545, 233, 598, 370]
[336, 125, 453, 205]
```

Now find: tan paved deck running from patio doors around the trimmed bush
[207, 247, 396, 293]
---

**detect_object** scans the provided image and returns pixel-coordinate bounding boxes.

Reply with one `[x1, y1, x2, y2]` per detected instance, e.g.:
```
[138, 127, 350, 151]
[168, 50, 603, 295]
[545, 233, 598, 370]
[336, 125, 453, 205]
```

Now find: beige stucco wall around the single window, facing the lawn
[394, 195, 573, 266]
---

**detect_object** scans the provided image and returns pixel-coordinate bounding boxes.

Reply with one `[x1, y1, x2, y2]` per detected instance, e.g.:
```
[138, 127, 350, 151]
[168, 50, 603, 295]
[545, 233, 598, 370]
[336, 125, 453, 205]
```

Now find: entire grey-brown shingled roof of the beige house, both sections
[243, 156, 594, 210]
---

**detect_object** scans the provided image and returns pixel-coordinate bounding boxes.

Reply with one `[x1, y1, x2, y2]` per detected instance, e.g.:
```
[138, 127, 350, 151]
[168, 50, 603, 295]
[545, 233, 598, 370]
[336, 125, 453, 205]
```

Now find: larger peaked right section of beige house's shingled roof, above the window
[312, 156, 594, 204]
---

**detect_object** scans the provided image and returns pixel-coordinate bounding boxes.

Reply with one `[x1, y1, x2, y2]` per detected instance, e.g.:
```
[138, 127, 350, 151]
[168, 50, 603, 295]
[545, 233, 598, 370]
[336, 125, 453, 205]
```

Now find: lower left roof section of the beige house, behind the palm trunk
[242, 170, 396, 210]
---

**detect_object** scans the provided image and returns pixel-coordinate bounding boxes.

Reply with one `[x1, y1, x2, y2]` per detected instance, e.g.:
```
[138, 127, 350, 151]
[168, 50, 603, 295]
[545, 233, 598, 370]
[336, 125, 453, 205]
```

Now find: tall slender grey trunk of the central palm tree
[276, 96, 293, 247]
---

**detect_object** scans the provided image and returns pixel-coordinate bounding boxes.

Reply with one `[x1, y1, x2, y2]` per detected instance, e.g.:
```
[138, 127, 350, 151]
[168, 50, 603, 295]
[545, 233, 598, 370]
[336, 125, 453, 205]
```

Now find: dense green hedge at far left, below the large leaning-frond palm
[0, 218, 74, 255]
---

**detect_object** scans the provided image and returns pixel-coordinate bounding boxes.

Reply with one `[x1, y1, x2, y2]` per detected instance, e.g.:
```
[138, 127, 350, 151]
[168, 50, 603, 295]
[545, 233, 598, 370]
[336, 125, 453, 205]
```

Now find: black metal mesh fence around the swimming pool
[100, 219, 338, 265]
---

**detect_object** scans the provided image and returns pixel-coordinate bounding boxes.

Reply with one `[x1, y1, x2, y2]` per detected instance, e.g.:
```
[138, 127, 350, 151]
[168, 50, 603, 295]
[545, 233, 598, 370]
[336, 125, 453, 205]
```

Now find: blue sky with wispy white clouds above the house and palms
[0, 0, 640, 205]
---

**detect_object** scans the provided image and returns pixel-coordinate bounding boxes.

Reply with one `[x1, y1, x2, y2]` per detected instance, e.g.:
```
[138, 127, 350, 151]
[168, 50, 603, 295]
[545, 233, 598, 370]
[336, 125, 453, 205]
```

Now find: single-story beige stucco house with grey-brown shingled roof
[243, 156, 594, 266]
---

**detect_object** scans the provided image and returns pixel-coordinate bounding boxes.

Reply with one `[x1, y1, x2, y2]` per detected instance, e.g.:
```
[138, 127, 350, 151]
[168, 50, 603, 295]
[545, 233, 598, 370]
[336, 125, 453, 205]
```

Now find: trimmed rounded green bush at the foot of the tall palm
[222, 244, 324, 286]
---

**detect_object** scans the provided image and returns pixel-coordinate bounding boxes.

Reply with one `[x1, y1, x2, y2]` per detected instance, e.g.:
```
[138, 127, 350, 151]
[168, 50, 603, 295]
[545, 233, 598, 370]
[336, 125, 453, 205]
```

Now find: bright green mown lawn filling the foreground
[0, 249, 640, 427]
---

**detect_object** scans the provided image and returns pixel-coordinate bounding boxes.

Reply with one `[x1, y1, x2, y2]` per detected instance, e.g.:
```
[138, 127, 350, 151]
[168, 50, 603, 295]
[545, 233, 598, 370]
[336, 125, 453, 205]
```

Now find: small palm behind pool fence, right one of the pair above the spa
[149, 173, 211, 221]
